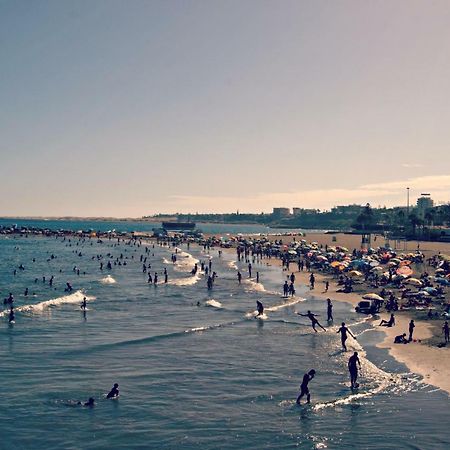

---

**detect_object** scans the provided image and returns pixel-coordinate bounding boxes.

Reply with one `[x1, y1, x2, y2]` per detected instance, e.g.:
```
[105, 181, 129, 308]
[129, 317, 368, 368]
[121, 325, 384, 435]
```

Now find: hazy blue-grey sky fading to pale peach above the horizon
[0, 0, 450, 217]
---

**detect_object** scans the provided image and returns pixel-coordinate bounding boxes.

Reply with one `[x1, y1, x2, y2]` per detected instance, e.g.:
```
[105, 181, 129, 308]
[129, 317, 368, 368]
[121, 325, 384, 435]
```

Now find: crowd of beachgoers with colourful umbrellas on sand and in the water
[0, 225, 450, 406]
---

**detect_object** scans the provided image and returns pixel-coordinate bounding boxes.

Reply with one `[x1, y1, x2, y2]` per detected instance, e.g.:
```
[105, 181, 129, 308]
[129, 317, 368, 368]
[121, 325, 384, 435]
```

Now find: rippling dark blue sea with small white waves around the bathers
[0, 219, 450, 450]
